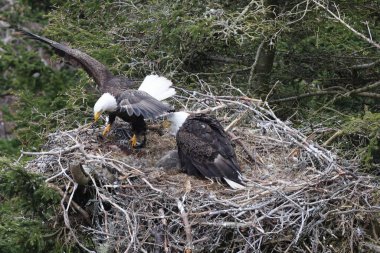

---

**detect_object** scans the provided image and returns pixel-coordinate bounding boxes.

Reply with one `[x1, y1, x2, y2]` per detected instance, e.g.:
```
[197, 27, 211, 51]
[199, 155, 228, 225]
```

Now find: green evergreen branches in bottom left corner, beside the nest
[0, 158, 76, 253]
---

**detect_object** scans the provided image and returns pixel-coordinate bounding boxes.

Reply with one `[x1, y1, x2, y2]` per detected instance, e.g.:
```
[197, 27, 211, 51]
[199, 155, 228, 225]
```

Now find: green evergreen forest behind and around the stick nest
[0, 0, 380, 252]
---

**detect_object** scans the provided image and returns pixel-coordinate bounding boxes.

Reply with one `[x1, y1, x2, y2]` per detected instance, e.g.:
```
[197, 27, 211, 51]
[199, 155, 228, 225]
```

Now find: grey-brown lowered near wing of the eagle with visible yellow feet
[117, 90, 172, 118]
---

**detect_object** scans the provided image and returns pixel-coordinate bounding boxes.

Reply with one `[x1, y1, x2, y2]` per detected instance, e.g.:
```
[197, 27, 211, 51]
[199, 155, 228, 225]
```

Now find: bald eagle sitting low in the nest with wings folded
[168, 112, 244, 189]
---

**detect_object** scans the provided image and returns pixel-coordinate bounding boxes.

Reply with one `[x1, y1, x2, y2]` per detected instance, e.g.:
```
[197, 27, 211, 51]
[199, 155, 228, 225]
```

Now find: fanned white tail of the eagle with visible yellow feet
[139, 75, 175, 101]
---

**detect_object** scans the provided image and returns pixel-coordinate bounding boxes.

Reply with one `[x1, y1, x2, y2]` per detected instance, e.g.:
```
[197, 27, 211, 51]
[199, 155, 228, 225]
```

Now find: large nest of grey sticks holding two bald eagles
[24, 87, 379, 252]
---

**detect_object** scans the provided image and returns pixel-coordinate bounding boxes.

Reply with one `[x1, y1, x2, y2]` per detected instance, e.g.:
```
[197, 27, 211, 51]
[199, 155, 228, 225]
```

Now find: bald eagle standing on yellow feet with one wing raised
[20, 30, 175, 147]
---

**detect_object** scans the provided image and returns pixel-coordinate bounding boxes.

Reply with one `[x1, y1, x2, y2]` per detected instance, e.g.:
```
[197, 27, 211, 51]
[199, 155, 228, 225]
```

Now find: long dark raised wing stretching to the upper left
[20, 30, 113, 87]
